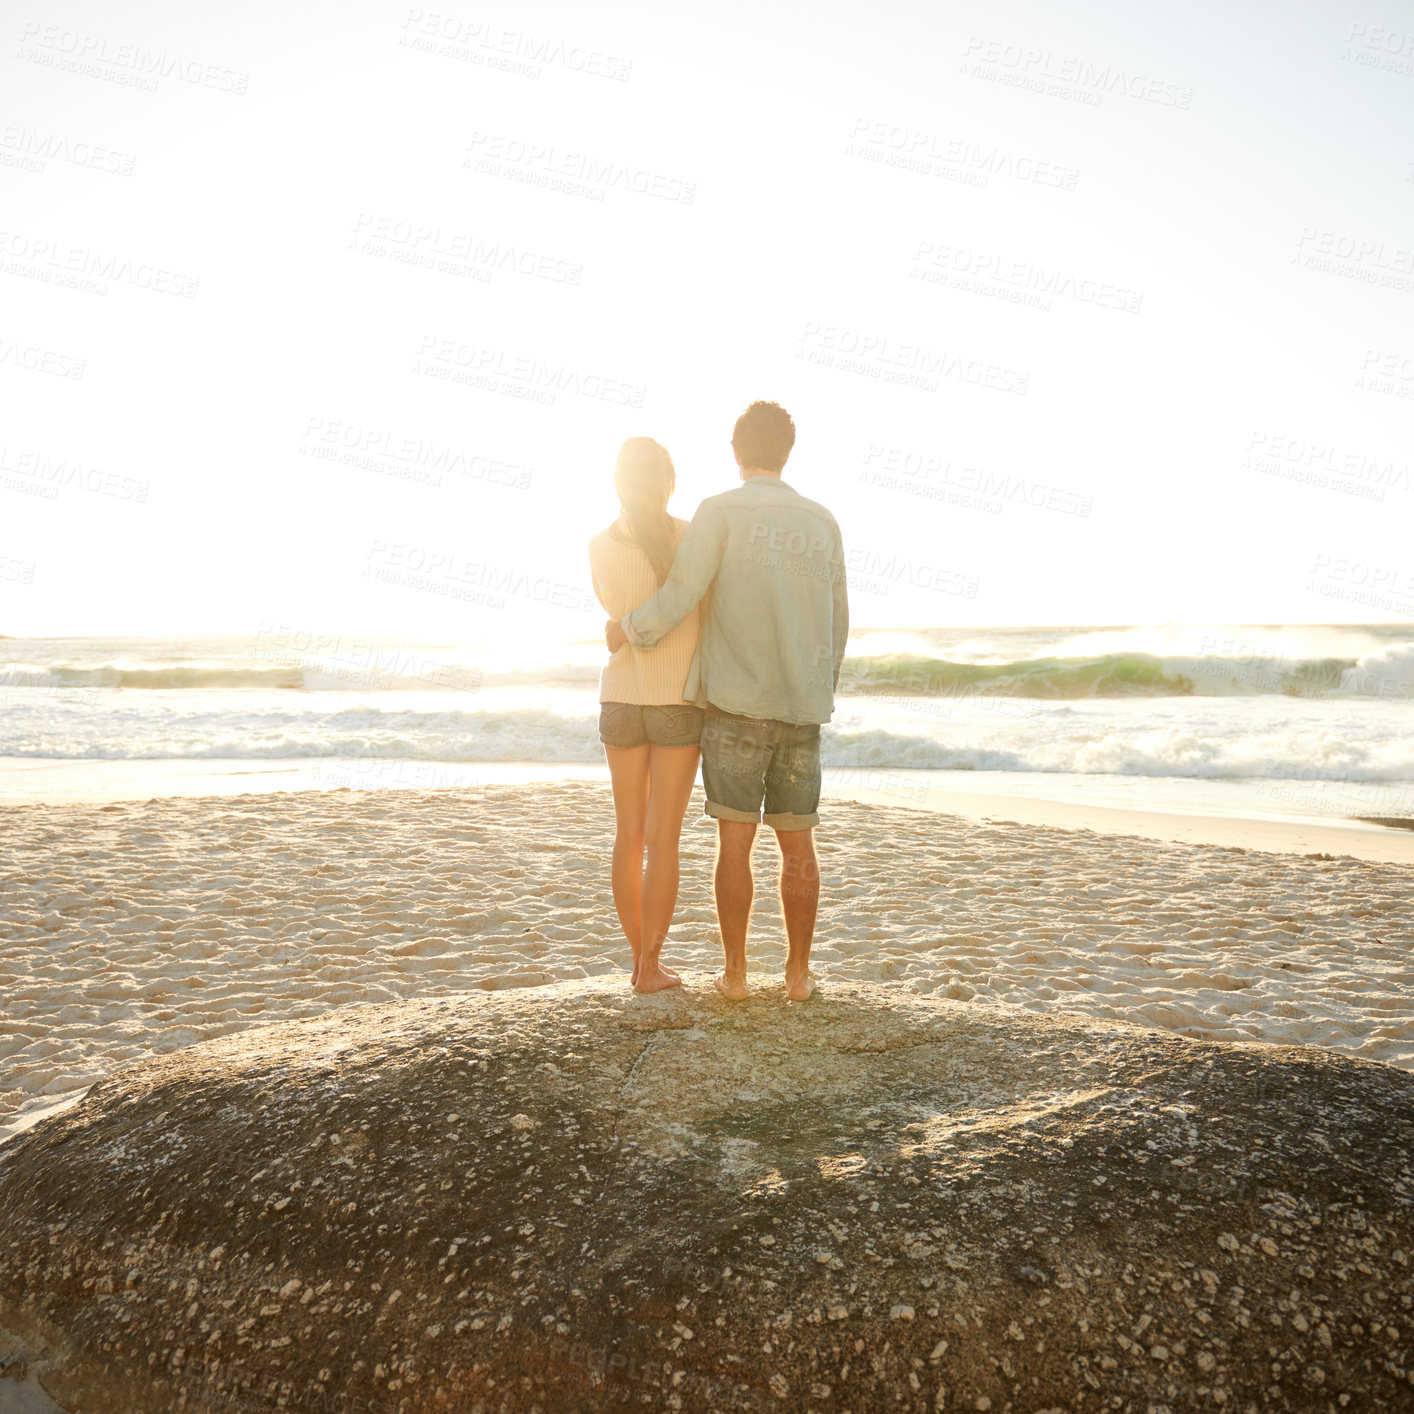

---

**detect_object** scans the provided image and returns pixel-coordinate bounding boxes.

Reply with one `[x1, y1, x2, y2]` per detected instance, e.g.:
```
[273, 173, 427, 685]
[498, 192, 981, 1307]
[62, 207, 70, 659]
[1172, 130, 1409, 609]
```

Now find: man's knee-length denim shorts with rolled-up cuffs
[703, 711, 820, 830]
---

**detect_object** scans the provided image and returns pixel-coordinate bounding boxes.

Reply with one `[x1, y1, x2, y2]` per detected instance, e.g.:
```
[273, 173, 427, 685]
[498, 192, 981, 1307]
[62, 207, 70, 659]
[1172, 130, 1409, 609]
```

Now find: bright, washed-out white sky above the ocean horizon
[0, 0, 1414, 639]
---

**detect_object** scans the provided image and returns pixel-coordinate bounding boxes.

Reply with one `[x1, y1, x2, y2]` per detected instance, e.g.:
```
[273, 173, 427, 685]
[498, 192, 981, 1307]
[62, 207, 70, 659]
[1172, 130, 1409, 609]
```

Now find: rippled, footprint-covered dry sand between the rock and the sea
[0, 782, 1414, 1134]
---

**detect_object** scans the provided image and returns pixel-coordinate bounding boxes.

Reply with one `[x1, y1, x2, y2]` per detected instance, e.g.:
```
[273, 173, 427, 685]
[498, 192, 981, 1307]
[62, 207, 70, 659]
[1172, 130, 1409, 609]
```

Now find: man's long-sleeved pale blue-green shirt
[622, 477, 850, 725]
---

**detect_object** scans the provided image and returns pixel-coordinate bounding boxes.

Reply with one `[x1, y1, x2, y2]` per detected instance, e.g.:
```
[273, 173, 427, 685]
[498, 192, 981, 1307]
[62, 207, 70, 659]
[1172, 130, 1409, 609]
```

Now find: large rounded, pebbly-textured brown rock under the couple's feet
[0, 980, 1414, 1414]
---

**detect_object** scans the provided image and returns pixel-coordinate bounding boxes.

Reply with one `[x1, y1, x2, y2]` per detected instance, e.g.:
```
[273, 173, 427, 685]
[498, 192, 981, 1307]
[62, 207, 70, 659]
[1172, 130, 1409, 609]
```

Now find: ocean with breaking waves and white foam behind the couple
[0, 625, 1414, 819]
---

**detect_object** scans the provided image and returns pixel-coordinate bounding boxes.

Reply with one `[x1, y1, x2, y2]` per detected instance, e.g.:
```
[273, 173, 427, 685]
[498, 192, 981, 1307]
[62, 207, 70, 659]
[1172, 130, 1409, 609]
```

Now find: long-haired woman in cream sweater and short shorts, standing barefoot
[590, 437, 703, 991]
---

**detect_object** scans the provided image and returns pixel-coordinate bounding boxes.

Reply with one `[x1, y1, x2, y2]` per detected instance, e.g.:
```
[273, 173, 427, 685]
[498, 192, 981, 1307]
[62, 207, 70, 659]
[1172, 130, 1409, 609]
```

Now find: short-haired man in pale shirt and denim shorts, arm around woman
[605, 403, 850, 1001]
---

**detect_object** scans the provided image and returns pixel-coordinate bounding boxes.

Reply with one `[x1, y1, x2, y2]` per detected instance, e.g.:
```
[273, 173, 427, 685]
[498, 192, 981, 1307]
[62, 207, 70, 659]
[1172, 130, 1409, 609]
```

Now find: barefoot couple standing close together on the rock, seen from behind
[590, 403, 850, 1001]
